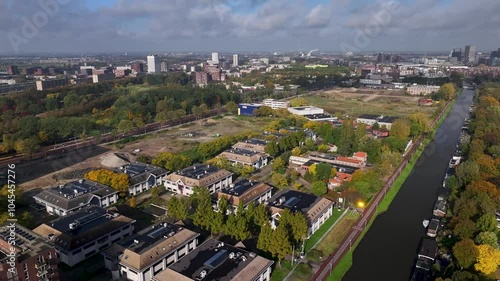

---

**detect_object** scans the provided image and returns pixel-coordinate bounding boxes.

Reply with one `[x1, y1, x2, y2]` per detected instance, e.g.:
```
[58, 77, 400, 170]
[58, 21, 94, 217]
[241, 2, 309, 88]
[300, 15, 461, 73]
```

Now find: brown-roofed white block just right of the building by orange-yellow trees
[164, 164, 233, 196]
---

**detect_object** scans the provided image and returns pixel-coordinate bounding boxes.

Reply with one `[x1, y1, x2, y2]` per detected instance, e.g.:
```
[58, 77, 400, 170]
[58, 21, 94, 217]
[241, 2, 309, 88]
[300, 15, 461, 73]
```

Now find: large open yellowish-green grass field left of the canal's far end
[304, 90, 437, 117]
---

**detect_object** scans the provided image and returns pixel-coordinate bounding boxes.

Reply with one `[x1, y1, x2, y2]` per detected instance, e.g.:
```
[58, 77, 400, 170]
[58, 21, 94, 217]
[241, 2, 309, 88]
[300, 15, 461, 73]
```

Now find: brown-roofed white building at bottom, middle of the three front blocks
[102, 223, 200, 281]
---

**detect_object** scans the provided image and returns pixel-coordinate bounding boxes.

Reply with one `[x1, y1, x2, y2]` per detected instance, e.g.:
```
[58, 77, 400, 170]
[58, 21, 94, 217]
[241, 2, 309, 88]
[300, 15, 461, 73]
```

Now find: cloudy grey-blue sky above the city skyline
[0, 0, 500, 54]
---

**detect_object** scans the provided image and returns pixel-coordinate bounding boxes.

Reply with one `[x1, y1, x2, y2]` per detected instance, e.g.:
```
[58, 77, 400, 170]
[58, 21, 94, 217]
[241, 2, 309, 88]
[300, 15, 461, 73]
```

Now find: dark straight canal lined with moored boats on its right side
[342, 89, 474, 281]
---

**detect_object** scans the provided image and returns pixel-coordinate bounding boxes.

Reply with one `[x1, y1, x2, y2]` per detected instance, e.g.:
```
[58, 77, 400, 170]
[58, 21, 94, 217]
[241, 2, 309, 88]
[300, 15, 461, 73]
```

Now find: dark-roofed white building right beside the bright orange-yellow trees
[117, 162, 170, 196]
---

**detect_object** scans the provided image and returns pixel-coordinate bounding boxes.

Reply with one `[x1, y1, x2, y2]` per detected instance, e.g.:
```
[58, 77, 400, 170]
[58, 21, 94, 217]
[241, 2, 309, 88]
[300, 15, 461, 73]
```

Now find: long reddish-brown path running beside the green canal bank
[311, 97, 452, 281]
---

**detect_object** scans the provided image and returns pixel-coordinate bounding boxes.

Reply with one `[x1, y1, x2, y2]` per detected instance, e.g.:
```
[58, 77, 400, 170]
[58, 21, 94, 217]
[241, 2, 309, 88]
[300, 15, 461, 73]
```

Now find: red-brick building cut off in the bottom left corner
[0, 223, 61, 281]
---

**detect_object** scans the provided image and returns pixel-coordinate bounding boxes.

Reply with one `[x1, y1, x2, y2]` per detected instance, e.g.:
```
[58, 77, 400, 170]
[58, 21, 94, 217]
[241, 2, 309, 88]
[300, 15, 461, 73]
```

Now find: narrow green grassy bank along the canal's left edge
[327, 91, 462, 281]
